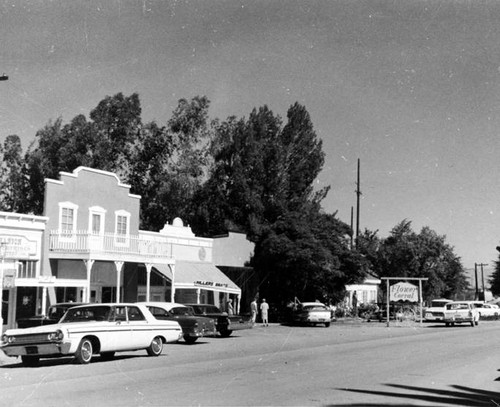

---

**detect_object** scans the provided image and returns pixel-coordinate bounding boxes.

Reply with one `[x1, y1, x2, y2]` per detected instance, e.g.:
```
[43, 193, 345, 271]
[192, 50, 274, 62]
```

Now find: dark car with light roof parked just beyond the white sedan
[141, 302, 216, 344]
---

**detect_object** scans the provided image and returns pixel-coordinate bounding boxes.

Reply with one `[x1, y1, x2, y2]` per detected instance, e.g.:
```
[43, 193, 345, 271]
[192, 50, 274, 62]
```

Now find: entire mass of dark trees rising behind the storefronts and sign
[0, 93, 466, 303]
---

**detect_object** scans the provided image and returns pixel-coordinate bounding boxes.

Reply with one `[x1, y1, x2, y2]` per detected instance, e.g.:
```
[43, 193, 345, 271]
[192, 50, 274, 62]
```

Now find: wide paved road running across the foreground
[0, 321, 500, 407]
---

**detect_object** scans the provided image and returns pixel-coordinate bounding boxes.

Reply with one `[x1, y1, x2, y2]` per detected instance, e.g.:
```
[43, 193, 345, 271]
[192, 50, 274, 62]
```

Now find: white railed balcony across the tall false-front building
[49, 230, 172, 261]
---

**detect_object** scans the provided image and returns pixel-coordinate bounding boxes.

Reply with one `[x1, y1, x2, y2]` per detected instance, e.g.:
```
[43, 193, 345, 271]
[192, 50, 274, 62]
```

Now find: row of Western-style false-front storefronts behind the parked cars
[0, 167, 248, 334]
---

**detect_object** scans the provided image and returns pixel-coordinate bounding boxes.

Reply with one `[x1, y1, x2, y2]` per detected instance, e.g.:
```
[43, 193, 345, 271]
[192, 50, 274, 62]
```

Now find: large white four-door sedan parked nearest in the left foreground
[0, 304, 182, 366]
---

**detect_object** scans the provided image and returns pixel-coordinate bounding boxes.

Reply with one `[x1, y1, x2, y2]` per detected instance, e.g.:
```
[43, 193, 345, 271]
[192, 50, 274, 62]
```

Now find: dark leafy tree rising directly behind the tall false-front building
[26, 93, 141, 214]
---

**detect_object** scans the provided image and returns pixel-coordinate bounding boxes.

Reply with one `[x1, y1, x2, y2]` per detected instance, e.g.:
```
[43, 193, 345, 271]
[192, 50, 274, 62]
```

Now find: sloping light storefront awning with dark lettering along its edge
[174, 260, 241, 294]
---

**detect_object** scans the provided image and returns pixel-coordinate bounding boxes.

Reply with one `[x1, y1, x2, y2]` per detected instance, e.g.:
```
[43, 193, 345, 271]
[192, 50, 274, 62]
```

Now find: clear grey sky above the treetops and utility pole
[0, 0, 500, 268]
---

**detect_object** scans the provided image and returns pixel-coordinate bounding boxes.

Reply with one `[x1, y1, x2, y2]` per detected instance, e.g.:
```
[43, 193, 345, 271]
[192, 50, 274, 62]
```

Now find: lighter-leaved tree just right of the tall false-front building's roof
[129, 96, 212, 230]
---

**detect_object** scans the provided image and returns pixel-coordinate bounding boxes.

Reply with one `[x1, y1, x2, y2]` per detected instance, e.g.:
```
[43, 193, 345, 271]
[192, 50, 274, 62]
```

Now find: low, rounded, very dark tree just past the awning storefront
[252, 210, 367, 304]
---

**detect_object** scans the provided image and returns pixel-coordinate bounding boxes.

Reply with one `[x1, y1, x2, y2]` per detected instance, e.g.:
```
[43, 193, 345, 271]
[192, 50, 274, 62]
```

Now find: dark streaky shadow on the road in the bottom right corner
[325, 384, 500, 407]
